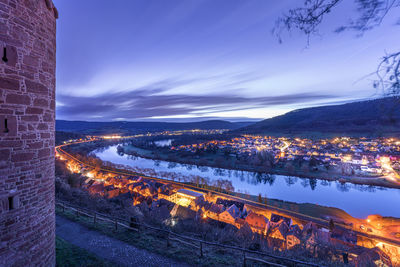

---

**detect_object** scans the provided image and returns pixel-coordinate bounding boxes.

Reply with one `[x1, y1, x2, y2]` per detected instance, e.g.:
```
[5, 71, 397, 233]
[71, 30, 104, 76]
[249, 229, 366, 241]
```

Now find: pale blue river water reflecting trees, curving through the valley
[94, 146, 400, 218]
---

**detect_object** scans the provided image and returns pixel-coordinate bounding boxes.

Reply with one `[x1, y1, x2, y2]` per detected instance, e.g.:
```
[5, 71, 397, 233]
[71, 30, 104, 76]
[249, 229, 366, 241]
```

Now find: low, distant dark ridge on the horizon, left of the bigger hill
[56, 120, 251, 134]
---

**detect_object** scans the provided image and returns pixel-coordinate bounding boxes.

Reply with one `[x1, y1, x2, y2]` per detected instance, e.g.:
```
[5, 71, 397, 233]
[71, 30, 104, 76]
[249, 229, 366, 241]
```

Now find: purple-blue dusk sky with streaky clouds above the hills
[54, 0, 400, 121]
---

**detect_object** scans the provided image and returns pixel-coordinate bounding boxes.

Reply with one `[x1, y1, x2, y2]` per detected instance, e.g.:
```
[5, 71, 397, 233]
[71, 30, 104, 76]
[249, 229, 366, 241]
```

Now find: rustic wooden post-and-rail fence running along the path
[56, 201, 321, 267]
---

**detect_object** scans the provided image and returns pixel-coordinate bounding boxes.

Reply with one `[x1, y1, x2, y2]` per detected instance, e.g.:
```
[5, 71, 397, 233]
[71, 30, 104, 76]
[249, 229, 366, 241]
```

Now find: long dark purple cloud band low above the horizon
[57, 79, 337, 120]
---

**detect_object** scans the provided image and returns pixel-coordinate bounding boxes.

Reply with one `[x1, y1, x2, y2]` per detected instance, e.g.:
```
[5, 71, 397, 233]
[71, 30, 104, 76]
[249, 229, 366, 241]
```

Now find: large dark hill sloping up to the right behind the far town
[236, 97, 400, 136]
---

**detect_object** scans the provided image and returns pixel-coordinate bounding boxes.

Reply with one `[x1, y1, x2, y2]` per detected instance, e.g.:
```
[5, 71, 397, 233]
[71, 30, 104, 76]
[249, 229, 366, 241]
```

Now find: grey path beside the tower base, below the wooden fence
[56, 216, 188, 266]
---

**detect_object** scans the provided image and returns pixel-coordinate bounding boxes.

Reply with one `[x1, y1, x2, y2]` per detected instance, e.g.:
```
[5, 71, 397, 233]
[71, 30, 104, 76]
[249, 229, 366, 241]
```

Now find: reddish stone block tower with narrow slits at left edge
[0, 0, 58, 266]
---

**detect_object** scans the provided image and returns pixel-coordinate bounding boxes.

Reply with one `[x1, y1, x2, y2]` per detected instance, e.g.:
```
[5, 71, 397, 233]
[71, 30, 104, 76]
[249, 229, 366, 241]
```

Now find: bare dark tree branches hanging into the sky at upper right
[272, 0, 400, 95]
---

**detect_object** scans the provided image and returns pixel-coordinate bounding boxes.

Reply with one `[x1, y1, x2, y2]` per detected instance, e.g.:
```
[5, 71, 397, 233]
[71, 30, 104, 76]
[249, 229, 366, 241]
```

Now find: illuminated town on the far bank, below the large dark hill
[171, 135, 400, 185]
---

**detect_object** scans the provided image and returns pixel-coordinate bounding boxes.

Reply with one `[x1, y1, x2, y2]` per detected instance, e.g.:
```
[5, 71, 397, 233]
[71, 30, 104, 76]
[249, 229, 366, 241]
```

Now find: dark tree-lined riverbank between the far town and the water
[123, 145, 400, 189]
